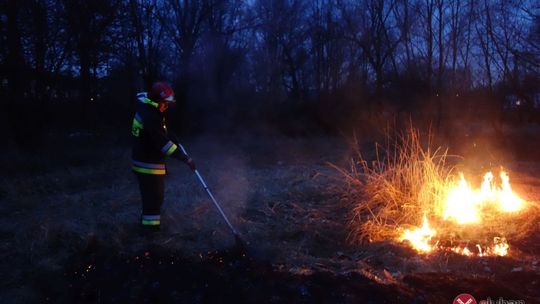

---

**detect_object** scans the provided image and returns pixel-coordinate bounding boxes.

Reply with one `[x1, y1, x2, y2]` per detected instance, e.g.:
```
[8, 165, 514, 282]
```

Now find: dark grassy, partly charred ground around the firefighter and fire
[0, 124, 540, 303]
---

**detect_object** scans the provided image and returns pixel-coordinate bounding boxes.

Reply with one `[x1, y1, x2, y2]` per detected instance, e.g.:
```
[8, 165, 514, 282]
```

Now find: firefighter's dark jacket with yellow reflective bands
[131, 93, 188, 175]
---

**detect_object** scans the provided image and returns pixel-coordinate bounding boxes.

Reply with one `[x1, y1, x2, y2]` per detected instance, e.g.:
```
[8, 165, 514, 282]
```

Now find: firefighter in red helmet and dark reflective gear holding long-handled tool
[131, 82, 195, 231]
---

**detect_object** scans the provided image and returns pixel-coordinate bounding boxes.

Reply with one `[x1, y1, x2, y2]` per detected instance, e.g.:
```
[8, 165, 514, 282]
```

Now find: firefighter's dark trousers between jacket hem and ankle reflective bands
[135, 173, 165, 215]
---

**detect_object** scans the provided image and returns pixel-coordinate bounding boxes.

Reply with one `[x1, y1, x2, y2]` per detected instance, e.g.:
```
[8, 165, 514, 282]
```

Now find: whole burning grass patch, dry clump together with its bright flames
[336, 126, 538, 255]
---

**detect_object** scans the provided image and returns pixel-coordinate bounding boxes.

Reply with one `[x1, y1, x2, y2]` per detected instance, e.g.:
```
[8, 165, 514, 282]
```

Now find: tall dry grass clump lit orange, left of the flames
[338, 126, 452, 241]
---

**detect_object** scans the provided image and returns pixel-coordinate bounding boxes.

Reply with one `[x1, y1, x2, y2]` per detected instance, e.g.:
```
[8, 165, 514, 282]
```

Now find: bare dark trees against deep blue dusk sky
[0, 0, 540, 135]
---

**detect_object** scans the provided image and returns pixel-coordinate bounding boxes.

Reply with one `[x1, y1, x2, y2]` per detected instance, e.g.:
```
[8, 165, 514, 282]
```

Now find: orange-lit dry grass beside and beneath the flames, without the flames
[334, 125, 539, 246]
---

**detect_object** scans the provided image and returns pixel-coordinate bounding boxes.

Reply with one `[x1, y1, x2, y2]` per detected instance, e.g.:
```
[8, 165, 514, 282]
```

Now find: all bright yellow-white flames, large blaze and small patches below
[399, 170, 525, 256]
